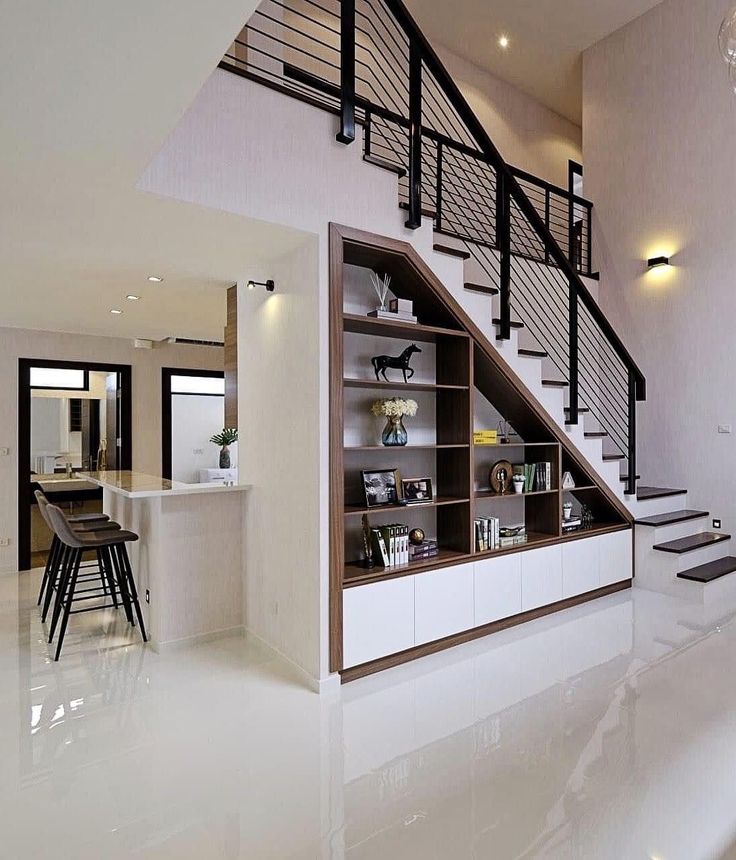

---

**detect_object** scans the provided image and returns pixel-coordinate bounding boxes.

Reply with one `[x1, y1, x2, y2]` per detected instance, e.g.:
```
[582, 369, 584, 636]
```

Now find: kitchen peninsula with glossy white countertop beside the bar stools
[83, 471, 248, 650]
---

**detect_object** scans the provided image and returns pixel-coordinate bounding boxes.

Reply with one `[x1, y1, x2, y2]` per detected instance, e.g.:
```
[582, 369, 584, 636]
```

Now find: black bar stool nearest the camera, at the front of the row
[46, 504, 148, 661]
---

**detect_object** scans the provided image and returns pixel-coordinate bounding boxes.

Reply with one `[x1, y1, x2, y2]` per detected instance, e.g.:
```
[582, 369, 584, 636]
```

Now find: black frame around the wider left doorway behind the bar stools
[18, 358, 133, 570]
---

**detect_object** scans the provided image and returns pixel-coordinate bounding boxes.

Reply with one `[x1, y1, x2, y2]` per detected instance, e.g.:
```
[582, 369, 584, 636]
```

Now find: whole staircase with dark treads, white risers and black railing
[220, 0, 736, 595]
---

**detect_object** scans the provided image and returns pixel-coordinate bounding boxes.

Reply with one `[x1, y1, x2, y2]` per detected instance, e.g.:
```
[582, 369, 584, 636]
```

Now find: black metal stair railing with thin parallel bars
[221, 0, 646, 493]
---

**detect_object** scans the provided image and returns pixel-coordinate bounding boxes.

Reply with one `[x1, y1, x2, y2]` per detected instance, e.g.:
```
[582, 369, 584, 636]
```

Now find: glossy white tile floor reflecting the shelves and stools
[0, 574, 736, 860]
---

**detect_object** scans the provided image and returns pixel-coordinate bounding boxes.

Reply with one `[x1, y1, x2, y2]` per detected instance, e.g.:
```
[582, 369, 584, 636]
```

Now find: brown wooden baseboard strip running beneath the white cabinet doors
[340, 579, 632, 684]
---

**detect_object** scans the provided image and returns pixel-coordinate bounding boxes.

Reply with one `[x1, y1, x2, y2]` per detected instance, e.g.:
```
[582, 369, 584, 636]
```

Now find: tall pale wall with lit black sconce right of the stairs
[583, 0, 736, 529]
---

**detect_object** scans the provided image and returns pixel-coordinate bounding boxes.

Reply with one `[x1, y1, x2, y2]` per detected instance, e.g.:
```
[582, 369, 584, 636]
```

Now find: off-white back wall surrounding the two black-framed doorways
[0, 330, 224, 571]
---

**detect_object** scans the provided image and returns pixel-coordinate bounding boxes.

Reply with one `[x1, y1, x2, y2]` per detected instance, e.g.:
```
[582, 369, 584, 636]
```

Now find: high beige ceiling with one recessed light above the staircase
[406, 0, 661, 125]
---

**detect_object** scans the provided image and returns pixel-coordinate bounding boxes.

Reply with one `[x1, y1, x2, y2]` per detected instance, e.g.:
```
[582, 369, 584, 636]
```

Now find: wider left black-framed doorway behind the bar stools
[18, 358, 132, 570]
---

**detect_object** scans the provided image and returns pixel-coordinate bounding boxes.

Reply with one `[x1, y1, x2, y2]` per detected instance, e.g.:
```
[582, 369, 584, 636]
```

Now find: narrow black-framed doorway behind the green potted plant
[161, 367, 225, 484]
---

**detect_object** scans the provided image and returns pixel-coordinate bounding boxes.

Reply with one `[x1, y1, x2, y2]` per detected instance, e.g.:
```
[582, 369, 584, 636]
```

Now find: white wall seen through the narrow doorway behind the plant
[171, 394, 225, 484]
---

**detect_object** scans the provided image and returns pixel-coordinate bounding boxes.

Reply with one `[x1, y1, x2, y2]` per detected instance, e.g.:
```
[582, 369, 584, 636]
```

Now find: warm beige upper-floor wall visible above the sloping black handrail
[437, 45, 587, 188]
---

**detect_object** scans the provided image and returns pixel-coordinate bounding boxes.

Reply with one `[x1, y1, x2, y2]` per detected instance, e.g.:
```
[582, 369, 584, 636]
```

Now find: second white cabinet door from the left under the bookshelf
[414, 564, 473, 645]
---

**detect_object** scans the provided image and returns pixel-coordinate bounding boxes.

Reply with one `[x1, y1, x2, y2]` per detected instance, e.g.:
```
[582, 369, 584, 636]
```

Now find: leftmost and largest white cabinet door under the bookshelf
[342, 576, 414, 669]
